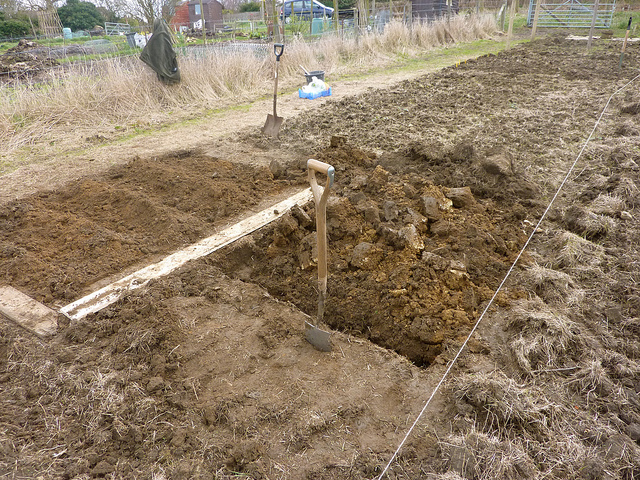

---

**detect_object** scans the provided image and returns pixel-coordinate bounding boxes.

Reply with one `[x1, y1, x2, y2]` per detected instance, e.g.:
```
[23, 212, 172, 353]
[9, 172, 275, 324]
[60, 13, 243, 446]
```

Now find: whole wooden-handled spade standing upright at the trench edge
[304, 159, 335, 352]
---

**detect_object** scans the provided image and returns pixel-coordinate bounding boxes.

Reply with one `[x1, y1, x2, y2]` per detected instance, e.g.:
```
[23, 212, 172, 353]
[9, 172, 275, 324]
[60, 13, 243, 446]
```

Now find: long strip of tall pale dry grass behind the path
[0, 15, 495, 163]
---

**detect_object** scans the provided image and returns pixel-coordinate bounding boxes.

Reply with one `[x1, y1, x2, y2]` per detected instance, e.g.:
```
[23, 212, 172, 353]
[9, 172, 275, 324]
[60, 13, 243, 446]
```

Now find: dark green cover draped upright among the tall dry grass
[140, 19, 180, 84]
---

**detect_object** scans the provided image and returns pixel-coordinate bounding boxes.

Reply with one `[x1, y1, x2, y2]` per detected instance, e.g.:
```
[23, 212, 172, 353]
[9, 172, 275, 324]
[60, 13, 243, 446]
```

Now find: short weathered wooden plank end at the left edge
[0, 285, 58, 337]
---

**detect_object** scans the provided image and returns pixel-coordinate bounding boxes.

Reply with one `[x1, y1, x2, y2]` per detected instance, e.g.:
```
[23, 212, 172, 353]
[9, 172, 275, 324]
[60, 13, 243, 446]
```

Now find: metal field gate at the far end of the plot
[527, 0, 616, 28]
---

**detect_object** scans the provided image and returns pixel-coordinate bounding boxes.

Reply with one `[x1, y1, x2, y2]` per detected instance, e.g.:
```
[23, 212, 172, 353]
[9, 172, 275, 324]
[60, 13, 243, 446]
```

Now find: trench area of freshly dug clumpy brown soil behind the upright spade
[212, 141, 539, 366]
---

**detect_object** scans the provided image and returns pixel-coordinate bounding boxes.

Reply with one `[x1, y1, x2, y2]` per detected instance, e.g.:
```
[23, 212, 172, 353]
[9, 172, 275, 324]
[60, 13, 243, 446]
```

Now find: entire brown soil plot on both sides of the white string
[0, 37, 640, 479]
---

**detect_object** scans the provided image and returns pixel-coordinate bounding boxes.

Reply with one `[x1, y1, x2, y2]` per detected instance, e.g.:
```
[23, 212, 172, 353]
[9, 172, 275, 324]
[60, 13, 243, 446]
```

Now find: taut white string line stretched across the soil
[378, 74, 640, 480]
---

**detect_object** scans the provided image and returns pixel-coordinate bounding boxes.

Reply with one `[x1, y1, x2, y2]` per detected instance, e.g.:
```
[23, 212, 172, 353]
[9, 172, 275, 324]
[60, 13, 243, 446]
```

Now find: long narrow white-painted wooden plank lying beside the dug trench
[60, 188, 313, 320]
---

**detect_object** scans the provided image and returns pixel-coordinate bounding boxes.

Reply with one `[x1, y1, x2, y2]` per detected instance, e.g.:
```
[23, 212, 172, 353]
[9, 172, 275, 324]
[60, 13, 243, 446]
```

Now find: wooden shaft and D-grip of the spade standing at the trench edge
[307, 159, 335, 298]
